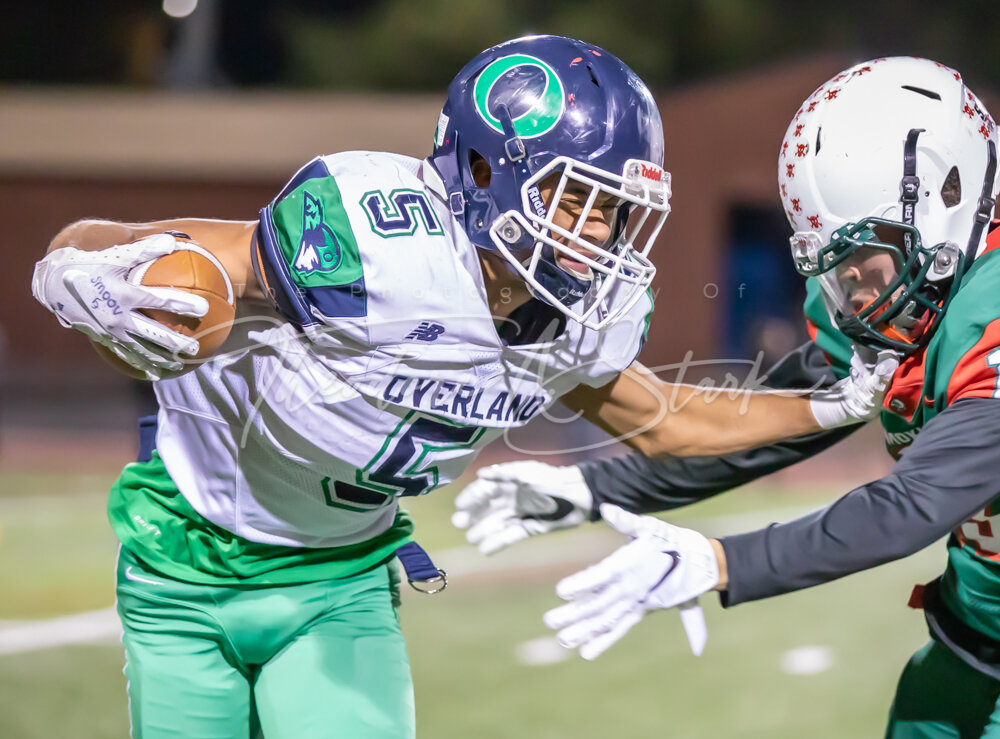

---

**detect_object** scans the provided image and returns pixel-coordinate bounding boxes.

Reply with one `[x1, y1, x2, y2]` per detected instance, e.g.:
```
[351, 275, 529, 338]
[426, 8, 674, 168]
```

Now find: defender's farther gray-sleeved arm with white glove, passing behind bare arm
[452, 341, 860, 554]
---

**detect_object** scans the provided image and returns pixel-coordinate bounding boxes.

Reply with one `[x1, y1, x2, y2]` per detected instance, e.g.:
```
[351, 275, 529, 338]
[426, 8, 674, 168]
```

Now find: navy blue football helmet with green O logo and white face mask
[430, 36, 670, 328]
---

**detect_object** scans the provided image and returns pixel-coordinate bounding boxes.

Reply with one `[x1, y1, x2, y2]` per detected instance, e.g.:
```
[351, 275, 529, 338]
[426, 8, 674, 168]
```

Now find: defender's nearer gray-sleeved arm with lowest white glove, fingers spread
[545, 398, 1000, 659]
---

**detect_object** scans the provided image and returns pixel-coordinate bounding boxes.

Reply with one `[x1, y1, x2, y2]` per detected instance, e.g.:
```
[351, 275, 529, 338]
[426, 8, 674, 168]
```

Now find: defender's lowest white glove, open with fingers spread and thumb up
[545, 503, 719, 660]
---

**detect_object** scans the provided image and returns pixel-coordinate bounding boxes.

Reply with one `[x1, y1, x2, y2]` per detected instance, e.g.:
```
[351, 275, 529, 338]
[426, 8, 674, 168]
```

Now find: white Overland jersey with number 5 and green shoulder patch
[155, 152, 652, 547]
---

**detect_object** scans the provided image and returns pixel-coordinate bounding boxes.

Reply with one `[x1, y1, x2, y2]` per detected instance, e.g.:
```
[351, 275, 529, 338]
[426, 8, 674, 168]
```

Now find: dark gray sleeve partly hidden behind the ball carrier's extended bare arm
[580, 341, 861, 519]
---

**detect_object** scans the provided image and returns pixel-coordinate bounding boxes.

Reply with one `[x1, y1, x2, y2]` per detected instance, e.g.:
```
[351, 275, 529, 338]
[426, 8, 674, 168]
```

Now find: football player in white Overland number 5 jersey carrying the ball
[33, 36, 891, 739]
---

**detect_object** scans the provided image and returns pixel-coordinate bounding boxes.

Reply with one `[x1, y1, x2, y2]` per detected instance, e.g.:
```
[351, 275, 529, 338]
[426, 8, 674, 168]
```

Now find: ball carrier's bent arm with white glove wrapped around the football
[32, 219, 255, 380]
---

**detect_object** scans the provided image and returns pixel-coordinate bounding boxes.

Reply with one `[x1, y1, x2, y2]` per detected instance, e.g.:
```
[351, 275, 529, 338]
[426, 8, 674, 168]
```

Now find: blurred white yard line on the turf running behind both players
[0, 507, 813, 655]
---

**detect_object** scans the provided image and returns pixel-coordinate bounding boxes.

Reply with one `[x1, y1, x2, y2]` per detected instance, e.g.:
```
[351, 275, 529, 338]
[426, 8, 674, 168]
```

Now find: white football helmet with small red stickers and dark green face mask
[778, 57, 998, 352]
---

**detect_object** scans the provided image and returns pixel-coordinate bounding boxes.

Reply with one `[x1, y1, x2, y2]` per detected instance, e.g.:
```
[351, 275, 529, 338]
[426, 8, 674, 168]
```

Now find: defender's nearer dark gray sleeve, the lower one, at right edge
[721, 398, 1000, 606]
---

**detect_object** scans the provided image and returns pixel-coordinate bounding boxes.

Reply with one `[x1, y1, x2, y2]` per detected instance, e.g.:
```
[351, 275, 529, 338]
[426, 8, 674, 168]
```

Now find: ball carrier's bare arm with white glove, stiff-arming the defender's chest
[562, 355, 898, 457]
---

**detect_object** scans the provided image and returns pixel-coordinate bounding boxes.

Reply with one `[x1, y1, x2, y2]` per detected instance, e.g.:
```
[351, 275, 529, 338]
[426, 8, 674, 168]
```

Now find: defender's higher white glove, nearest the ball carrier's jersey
[451, 461, 594, 554]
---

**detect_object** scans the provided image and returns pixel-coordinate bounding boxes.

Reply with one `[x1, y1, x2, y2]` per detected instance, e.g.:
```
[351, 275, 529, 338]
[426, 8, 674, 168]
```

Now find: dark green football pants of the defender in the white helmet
[885, 639, 1000, 739]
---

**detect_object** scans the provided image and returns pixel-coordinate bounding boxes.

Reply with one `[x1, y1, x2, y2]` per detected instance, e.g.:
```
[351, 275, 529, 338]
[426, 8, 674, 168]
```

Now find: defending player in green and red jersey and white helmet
[456, 58, 1000, 737]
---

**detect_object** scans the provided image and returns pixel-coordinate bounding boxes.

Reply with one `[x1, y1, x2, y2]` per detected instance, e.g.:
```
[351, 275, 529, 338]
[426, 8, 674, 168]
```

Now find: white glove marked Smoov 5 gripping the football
[31, 233, 208, 380]
